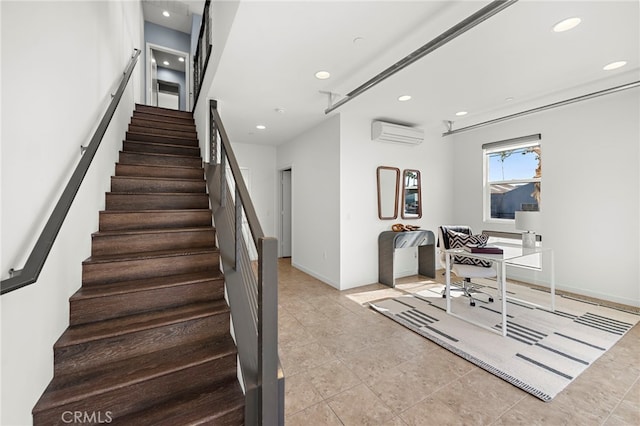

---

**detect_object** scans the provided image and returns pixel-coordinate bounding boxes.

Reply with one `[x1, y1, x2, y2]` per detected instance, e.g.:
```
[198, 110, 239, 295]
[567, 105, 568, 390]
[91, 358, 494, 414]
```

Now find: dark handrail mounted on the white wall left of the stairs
[0, 49, 140, 294]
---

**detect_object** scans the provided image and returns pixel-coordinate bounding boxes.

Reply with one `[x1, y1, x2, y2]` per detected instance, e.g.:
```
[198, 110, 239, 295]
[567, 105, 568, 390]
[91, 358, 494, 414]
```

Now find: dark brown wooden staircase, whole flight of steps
[33, 105, 244, 426]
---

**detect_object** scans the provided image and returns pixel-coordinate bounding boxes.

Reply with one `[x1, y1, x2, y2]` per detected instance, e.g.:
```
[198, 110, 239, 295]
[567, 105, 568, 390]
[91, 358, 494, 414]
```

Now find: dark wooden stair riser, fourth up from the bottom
[82, 251, 220, 286]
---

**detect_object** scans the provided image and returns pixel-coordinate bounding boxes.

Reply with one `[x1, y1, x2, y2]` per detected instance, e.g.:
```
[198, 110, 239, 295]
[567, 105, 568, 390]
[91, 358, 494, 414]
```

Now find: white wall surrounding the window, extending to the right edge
[445, 88, 640, 306]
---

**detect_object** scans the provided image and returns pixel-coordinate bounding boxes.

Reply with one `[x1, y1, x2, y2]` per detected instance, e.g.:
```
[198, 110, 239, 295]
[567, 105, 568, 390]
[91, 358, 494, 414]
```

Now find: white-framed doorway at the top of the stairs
[146, 43, 193, 111]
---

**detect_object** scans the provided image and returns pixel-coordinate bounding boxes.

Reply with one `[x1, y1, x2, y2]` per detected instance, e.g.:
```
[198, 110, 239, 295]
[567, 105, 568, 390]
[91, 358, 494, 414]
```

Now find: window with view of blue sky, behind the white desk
[482, 134, 542, 220]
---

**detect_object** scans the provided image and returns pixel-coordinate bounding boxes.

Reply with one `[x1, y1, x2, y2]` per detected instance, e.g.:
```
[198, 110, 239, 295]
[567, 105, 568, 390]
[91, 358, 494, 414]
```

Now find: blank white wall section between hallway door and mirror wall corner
[277, 115, 341, 288]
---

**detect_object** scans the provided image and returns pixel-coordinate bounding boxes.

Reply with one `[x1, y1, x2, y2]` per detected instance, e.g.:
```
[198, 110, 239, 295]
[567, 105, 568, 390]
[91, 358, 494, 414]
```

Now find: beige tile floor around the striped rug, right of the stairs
[279, 259, 640, 426]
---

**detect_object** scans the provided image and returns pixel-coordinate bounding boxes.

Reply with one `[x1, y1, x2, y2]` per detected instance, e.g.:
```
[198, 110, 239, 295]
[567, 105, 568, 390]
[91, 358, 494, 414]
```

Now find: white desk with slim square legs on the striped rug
[445, 243, 556, 336]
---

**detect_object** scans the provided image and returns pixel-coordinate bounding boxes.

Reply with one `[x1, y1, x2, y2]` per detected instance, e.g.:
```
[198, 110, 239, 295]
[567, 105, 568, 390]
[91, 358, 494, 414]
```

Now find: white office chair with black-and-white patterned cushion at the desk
[438, 225, 496, 306]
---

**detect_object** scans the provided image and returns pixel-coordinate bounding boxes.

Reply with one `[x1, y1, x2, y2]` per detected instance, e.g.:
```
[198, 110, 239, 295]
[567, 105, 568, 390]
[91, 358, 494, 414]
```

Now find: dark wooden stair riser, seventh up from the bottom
[106, 193, 209, 210]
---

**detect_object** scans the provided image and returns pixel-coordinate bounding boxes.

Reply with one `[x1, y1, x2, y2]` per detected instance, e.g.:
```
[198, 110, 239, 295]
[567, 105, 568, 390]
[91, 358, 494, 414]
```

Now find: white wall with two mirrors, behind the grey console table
[340, 113, 453, 289]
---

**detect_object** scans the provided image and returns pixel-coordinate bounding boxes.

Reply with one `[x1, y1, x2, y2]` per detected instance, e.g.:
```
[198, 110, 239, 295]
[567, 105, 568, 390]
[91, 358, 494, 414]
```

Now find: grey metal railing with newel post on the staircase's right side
[207, 101, 284, 425]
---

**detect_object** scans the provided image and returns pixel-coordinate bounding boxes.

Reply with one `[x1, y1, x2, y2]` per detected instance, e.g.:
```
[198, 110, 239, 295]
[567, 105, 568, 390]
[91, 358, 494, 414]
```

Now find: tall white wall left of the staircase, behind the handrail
[0, 1, 143, 425]
